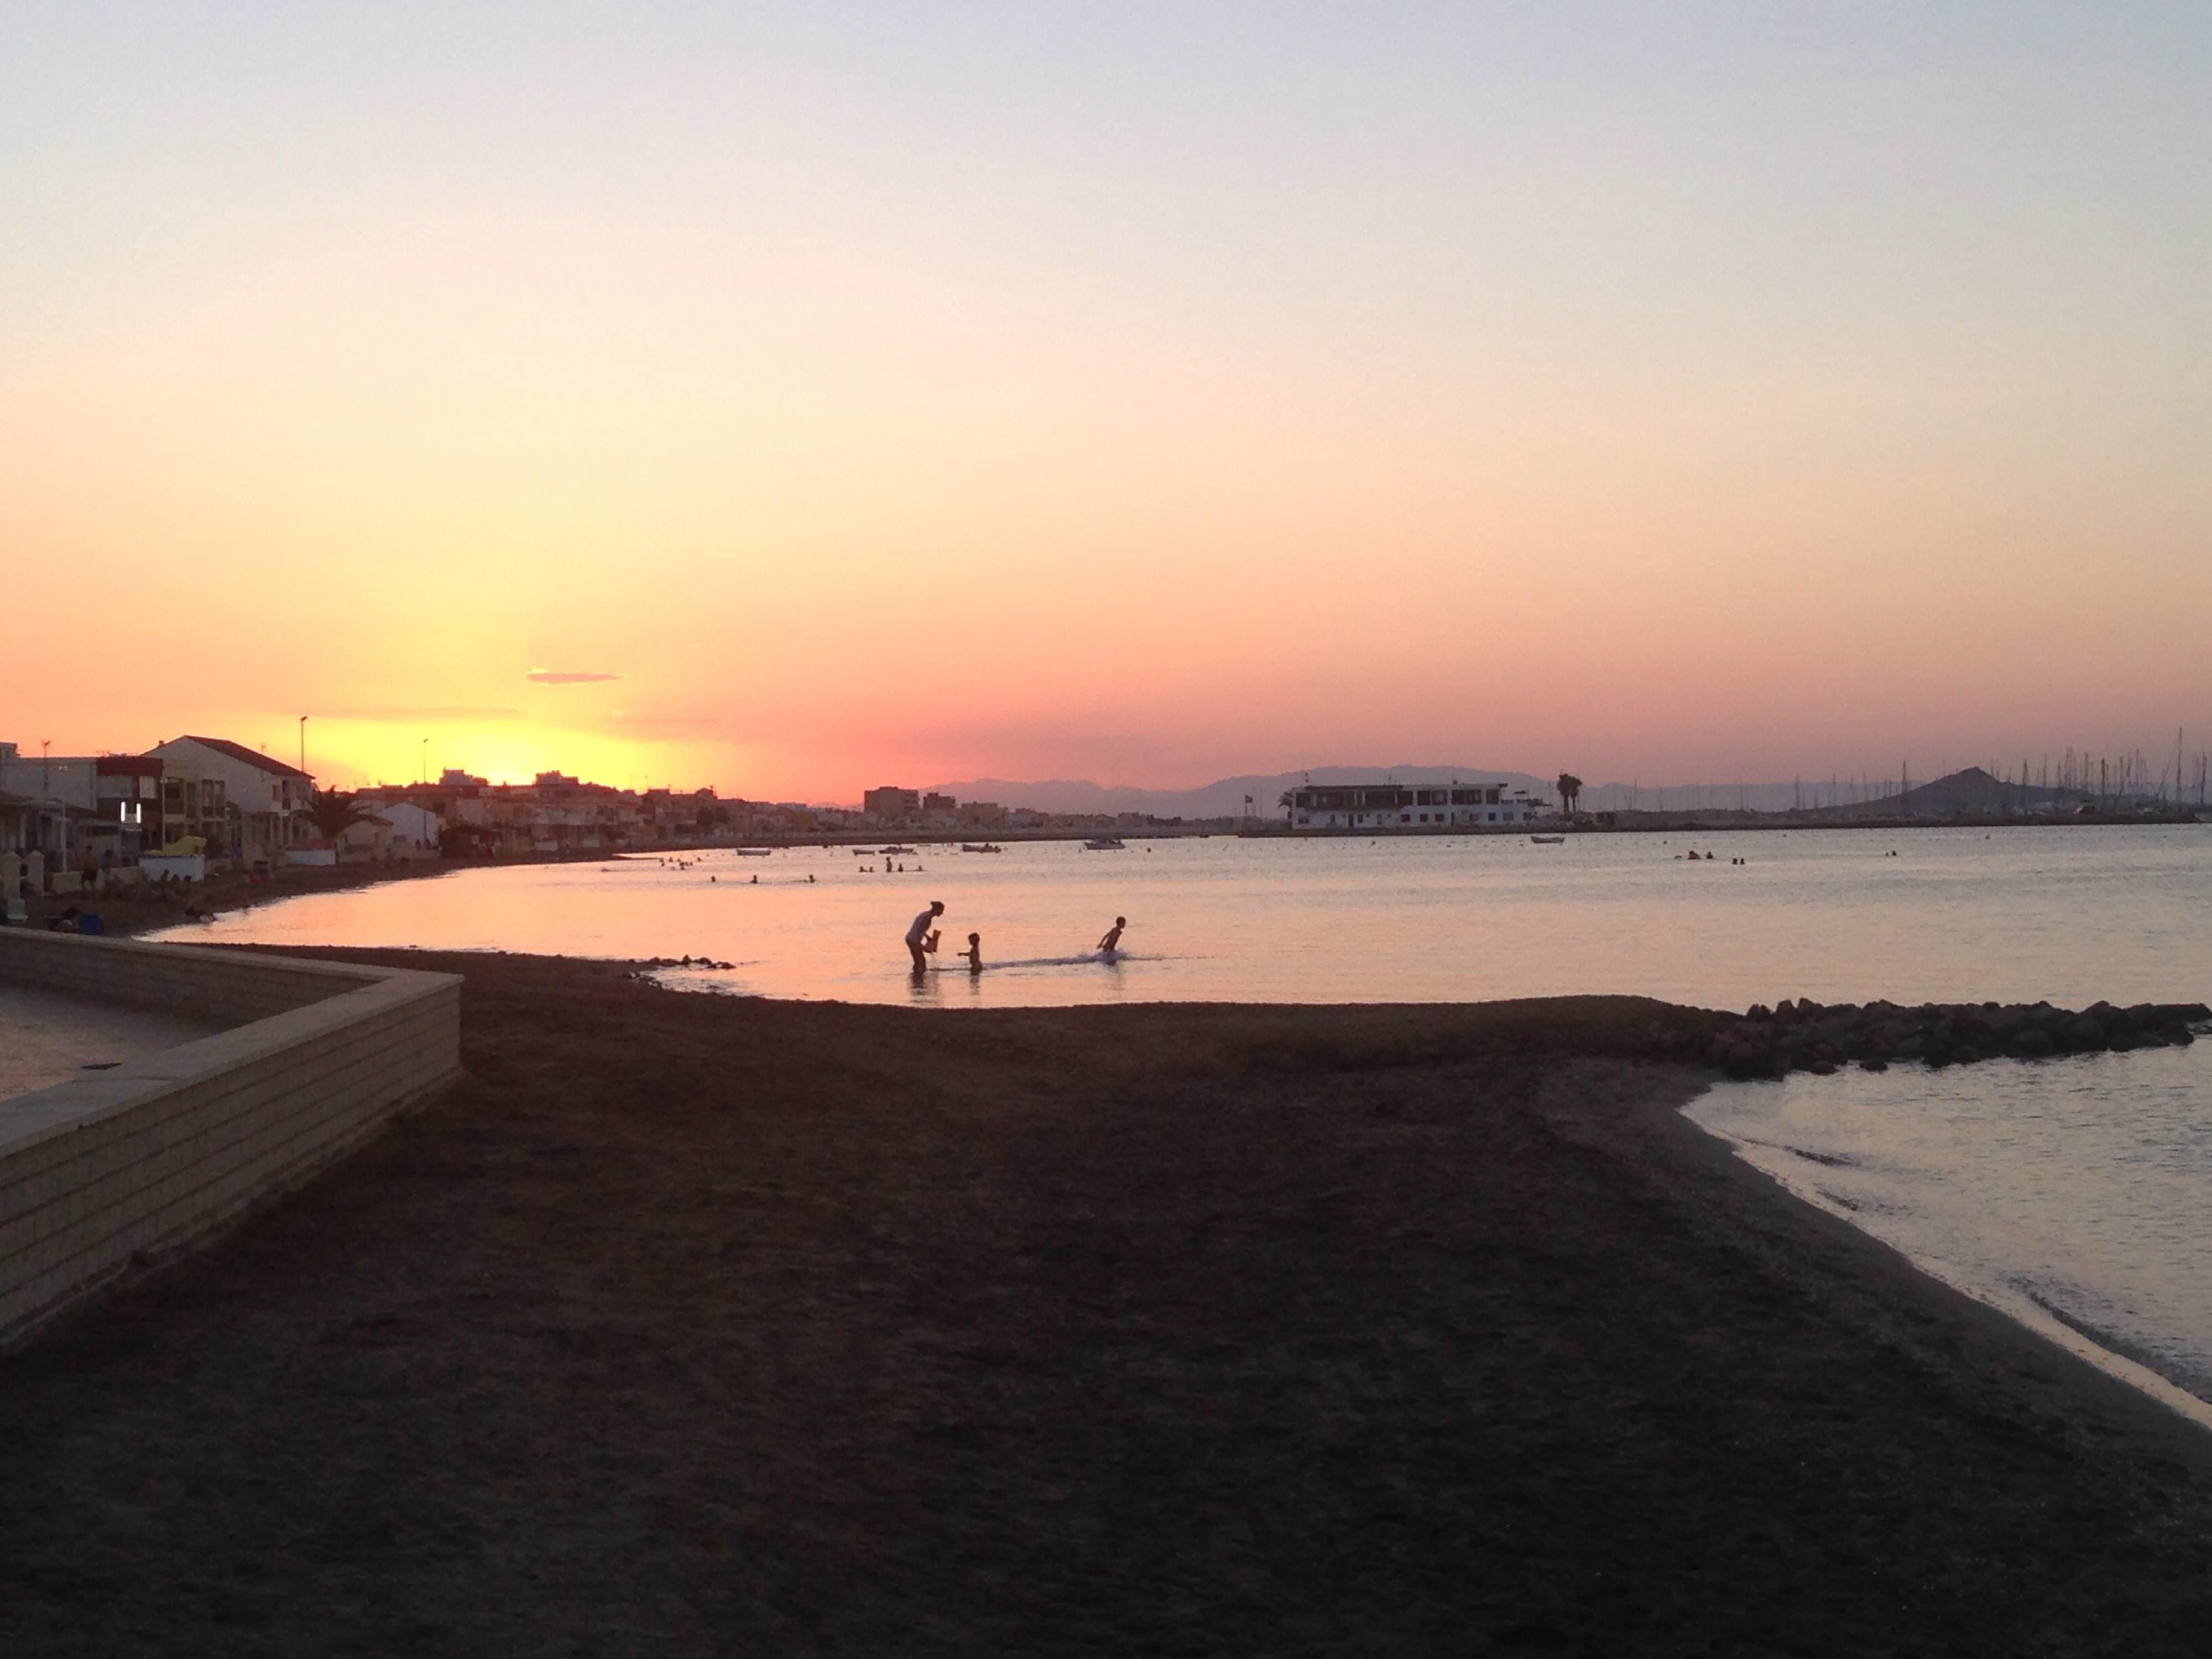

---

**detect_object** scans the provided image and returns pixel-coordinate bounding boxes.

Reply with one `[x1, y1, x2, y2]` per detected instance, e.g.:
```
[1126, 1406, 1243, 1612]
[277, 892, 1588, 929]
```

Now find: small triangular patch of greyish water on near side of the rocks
[1688, 1042, 2212, 1427]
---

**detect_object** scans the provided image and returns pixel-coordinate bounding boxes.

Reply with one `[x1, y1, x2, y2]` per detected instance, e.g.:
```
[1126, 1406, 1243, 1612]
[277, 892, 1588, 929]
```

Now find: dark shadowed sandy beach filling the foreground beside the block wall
[0, 958, 2212, 1655]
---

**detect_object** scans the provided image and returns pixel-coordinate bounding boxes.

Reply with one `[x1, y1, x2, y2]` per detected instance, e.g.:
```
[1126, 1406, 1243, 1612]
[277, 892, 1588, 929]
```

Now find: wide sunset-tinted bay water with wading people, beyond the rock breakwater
[156, 825, 2212, 1009]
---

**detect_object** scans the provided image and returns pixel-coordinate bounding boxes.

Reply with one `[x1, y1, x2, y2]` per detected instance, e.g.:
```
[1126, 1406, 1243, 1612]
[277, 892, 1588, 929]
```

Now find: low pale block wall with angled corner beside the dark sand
[0, 929, 460, 1340]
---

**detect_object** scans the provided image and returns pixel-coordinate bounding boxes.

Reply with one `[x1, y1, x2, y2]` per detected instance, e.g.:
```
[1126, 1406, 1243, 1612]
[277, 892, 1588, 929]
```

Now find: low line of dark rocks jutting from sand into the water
[1705, 998, 2212, 1077]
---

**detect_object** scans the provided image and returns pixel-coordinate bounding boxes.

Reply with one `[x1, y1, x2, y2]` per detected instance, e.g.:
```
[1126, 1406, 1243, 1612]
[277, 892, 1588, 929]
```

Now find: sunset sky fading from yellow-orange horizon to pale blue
[0, 0, 2212, 801]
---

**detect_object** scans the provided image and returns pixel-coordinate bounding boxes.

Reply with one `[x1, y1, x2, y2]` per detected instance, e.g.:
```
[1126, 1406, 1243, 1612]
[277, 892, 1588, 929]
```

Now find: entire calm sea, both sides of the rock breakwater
[168, 825, 2212, 1422]
